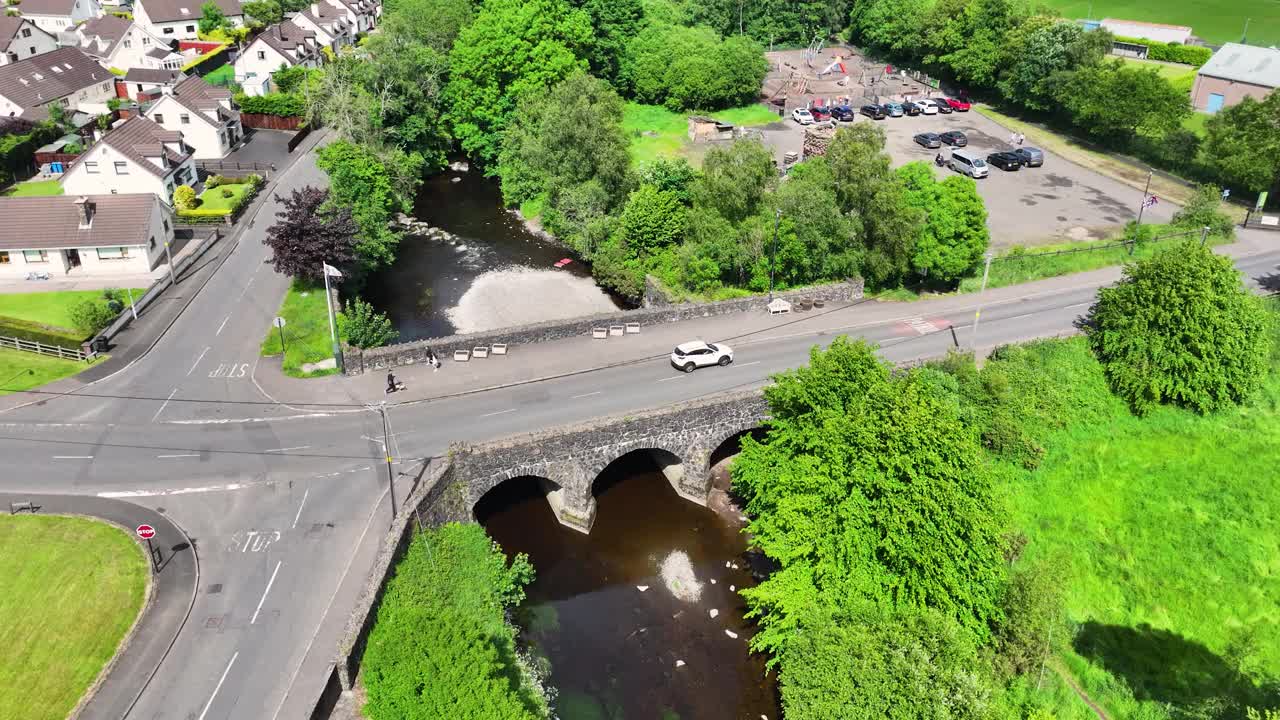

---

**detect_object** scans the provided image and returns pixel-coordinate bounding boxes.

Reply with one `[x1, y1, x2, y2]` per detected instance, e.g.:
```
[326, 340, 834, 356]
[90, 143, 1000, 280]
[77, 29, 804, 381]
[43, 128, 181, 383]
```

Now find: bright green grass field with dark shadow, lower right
[1010, 340, 1280, 719]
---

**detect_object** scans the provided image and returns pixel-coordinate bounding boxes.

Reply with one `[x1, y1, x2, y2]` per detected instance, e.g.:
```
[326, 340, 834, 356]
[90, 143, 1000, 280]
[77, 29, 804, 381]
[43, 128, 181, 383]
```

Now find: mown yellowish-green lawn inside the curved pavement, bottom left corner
[0, 514, 147, 720]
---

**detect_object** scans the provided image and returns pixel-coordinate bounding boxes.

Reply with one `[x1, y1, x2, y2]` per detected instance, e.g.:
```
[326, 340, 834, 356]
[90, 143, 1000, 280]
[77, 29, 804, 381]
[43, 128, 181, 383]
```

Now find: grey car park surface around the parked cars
[764, 111, 1176, 247]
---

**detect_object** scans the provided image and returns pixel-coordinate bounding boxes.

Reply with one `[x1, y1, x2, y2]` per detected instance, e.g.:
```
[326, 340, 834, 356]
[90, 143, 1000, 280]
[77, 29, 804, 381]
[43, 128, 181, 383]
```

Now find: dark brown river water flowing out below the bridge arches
[476, 454, 781, 720]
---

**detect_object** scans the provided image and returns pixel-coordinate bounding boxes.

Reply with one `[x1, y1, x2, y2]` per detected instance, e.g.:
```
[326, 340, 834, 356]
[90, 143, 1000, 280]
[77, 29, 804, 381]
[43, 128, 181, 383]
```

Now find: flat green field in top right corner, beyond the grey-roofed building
[1046, 0, 1280, 45]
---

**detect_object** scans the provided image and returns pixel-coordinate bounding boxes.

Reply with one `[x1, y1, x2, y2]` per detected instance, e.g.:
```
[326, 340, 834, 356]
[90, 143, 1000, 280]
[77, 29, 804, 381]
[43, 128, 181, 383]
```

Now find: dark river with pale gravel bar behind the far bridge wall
[361, 170, 618, 341]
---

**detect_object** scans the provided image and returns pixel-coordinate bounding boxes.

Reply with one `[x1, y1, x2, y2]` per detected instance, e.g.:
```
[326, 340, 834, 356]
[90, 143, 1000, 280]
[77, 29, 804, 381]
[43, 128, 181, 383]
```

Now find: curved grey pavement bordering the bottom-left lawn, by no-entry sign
[0, 493, 200, 720]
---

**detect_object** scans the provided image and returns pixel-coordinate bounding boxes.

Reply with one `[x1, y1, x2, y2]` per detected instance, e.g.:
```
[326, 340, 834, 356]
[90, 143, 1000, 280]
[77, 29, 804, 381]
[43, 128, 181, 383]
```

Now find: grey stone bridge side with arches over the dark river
[419, 389, 767, 533]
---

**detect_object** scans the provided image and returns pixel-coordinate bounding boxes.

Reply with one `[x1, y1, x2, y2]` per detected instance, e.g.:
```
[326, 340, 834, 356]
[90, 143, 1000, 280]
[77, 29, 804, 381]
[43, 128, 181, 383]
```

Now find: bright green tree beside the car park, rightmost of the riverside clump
[896, 163, 991, 283]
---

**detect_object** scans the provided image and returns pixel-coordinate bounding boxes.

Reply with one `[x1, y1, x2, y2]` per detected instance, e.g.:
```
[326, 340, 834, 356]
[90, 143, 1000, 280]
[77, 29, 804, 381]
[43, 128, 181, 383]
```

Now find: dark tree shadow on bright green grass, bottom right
[1074, 621, 1275, 720]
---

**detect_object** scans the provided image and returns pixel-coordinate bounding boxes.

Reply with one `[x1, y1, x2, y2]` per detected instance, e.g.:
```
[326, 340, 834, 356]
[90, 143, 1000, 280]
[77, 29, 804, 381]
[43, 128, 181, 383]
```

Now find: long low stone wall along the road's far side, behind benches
[343, 278, 863, 375]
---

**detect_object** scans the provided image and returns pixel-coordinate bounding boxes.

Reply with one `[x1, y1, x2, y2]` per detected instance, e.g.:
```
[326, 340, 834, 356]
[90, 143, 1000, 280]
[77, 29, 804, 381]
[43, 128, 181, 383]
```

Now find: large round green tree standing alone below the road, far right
[1083, 241, 1271, 415]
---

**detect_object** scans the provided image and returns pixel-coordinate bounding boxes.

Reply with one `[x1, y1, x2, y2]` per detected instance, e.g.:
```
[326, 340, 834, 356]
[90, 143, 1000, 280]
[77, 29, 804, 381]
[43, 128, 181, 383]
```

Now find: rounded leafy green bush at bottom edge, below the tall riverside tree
[780, 606, 992, 720]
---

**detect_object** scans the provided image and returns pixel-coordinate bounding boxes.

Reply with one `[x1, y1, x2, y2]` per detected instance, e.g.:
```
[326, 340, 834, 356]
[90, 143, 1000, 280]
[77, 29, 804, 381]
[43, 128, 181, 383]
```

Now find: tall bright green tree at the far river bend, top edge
[445, 0, 591, 165]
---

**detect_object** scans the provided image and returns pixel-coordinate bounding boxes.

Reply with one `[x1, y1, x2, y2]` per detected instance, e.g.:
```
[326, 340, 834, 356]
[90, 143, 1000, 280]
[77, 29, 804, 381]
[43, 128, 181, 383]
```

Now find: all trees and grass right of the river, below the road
[732, 242, 1280, 720]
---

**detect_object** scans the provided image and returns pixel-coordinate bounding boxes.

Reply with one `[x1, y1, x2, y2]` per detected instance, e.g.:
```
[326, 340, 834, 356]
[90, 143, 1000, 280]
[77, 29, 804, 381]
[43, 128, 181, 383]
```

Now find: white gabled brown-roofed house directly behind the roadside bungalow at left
[59, 117, 196, 202]
